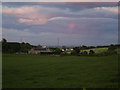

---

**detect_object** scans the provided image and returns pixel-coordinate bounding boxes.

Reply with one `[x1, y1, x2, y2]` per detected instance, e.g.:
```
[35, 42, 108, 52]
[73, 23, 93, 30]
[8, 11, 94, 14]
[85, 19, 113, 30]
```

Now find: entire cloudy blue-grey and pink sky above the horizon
[1, 0, 118, 46]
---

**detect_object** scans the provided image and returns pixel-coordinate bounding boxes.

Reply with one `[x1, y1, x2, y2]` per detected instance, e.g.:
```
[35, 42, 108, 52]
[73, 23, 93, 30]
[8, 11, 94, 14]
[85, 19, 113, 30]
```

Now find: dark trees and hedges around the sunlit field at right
[61, 44, 120, 56]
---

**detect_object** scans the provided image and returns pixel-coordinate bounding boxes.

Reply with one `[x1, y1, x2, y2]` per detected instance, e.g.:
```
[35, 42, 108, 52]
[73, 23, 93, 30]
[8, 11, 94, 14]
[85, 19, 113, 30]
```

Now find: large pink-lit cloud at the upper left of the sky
[3, 7, 48, 25]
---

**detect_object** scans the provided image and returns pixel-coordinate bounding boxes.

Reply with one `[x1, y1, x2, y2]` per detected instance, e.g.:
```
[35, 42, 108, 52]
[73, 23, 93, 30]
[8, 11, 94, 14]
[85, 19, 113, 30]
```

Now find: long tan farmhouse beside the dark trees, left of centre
[28, 47, 52, 54]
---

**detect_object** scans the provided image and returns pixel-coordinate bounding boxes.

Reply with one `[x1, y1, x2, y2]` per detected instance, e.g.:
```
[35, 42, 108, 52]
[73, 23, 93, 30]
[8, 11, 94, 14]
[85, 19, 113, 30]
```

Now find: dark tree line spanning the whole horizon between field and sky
[0, 38, 120, 55]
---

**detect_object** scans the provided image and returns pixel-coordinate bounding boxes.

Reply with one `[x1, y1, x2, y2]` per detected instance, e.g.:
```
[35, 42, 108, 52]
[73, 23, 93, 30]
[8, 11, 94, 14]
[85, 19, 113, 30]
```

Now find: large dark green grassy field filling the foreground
[3, 54, 118, 88]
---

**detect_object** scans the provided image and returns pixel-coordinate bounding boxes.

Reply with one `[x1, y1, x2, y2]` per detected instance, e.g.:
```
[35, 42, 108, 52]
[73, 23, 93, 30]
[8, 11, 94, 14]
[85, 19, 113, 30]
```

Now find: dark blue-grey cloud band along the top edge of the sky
[2, 2, 118, 12]
